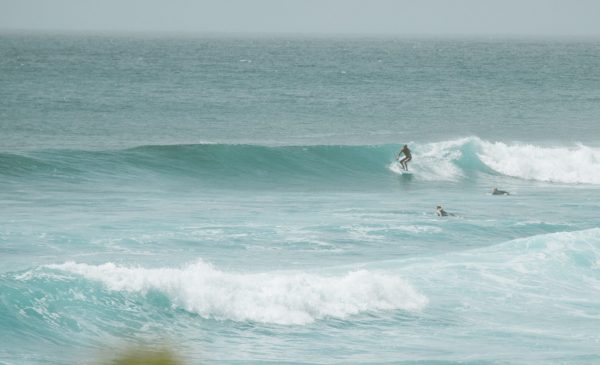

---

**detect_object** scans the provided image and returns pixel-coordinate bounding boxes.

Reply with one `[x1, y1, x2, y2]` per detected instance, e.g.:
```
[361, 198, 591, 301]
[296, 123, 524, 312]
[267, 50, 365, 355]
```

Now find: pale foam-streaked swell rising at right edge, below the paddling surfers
[405, 228, 600, 302]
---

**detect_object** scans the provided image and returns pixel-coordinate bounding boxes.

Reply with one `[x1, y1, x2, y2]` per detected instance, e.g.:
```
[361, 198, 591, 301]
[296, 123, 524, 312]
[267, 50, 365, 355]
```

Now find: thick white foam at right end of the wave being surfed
[479, 141, 600, 184]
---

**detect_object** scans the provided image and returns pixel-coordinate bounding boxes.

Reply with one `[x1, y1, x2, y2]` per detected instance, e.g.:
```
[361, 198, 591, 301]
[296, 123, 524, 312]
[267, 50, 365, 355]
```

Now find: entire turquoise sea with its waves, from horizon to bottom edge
[0, 33, 600, 365]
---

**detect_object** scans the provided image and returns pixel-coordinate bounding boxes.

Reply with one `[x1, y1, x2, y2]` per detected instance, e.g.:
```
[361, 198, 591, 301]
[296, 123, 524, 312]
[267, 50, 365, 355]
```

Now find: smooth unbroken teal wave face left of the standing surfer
[0, 144, 394, 186]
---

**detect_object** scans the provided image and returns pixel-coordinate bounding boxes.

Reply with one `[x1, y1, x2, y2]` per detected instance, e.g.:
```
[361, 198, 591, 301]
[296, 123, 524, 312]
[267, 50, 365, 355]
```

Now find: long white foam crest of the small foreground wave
[48, 260, 427, 324]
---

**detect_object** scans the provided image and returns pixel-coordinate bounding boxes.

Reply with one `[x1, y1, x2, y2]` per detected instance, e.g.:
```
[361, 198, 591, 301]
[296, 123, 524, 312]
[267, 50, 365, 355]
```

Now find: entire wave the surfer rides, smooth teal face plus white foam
[0, 137, 600, 186]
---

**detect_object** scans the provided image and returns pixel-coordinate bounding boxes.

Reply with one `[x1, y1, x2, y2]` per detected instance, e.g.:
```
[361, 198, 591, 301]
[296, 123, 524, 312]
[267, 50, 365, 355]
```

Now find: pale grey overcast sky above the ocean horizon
[0, 0, 600, 36]
